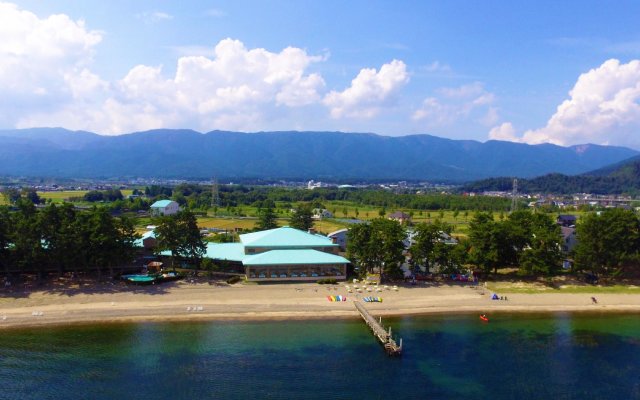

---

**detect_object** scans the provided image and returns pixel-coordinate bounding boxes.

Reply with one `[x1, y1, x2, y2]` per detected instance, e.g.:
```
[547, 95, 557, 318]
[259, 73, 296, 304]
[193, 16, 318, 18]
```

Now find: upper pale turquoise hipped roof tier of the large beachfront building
[240, 226, 337, 248]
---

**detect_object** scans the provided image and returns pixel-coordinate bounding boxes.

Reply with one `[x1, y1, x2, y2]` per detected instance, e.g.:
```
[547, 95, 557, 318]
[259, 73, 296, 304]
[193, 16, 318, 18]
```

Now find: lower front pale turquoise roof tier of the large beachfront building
[242, 249, 349, 265]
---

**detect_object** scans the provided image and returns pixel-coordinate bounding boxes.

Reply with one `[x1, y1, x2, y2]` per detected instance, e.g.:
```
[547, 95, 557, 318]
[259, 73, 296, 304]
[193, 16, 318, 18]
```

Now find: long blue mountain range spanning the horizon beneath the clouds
[0, 128, 639, 182]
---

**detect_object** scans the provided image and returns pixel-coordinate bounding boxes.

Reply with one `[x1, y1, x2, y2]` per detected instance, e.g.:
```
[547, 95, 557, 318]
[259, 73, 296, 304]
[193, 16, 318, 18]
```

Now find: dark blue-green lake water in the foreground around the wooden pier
[0, 314, 640, 399]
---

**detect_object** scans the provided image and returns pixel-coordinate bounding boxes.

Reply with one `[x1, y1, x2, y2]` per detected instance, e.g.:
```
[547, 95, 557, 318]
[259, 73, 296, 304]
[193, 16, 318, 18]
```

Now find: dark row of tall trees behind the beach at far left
[0, 198, 137, 278]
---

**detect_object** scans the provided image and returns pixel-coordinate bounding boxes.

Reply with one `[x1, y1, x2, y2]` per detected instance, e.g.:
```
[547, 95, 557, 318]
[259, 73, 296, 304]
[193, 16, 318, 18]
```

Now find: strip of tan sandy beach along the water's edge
[0, 281, 640, 329]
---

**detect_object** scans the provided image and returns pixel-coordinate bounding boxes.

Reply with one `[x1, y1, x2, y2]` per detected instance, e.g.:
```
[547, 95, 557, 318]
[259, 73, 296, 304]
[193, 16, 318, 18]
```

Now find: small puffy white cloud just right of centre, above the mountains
[323, 60, 409, 118]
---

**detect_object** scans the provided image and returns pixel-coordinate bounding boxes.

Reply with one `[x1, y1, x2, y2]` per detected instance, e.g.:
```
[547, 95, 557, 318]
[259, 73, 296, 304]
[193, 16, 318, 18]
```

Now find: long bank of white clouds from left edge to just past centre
[0, 0, 418, 134]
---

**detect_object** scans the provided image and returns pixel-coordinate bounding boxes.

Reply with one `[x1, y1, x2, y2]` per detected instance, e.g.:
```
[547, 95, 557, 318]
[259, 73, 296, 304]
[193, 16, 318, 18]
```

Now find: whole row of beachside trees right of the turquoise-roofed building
[347, 209, 640, 278]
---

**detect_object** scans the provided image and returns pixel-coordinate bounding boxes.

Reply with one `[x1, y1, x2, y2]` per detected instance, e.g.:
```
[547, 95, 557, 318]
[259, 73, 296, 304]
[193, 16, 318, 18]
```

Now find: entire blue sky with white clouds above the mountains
[0, 0, 640, 149]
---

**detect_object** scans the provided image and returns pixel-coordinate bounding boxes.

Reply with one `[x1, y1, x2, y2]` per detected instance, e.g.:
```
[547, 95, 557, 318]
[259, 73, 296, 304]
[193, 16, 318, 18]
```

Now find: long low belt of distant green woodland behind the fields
[145, 184, 511, 211]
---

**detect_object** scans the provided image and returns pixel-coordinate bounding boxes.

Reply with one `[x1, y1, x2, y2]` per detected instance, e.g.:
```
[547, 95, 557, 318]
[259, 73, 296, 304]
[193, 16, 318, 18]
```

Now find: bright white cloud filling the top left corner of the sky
[0, 3, 102, 125]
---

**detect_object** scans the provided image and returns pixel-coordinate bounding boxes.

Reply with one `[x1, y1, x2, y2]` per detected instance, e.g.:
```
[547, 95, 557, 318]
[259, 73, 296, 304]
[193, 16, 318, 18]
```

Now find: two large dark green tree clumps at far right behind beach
[467, 208, 640, 277]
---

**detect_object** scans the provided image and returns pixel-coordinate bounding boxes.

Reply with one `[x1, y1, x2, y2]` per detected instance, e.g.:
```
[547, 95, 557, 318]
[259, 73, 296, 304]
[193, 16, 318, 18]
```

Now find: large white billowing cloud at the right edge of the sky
[502, 59, 640, 148]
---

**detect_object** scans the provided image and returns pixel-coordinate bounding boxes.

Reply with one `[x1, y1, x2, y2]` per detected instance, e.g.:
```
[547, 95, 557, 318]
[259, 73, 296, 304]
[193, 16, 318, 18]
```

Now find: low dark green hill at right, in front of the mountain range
[461, 156, 640, 194]
